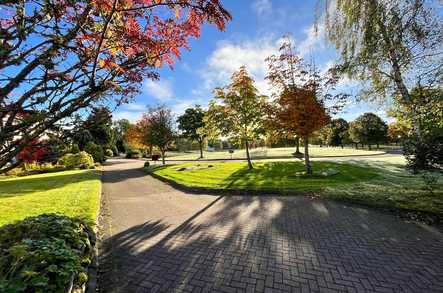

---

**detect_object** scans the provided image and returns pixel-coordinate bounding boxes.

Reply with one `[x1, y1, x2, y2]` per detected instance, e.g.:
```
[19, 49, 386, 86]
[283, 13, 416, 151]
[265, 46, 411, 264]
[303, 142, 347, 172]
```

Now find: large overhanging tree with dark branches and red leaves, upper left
[0, 0, 231, 172]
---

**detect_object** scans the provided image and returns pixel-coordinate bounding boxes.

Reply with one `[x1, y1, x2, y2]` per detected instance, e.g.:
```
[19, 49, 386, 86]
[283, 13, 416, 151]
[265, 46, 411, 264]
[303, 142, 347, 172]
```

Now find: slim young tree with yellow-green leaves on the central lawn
[204, 66, 268, 169]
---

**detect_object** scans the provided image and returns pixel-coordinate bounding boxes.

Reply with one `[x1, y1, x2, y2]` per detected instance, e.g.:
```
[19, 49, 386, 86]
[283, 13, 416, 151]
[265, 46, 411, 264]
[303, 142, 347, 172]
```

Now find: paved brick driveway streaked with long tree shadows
[99, 160, 443, 293]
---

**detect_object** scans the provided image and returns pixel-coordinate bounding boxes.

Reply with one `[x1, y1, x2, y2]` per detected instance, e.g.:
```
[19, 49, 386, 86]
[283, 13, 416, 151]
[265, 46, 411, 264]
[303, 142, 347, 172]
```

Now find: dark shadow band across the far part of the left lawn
[0, 170, 99, 198]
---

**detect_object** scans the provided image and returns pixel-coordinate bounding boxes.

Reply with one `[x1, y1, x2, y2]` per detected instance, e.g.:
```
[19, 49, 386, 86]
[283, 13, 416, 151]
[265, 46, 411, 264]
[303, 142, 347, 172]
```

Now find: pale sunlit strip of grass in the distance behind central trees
[166, 146, 384, 160]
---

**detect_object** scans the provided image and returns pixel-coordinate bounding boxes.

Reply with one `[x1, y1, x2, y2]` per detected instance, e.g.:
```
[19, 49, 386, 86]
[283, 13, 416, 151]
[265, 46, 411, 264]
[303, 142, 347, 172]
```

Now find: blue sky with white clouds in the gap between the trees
[113, 0, 386, 122]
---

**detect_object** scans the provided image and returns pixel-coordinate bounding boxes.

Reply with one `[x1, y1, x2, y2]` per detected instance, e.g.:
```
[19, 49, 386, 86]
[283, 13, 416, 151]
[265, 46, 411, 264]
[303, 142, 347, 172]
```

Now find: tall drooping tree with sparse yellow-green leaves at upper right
[323, 0, 443, 139]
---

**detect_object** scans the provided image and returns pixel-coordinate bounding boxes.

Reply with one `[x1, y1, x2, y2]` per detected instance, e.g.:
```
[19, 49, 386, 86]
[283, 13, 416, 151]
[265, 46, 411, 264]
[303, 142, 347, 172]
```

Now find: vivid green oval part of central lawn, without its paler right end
[154, 162, 376, 191]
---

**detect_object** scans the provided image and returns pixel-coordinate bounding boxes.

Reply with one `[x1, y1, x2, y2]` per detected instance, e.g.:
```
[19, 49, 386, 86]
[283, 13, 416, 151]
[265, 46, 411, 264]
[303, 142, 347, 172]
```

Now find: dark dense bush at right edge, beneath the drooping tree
[403, 136, 443, 172]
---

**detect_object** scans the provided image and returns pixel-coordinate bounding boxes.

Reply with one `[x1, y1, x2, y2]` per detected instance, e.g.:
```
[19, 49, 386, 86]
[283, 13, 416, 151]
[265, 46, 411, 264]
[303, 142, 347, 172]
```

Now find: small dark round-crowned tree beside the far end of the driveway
[143, 106, 174, 165]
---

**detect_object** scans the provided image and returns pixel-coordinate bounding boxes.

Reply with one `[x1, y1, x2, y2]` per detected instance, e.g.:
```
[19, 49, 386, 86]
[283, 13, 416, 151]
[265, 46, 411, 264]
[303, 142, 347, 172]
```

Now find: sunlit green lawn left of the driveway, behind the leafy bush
[0, 170, 100, 226]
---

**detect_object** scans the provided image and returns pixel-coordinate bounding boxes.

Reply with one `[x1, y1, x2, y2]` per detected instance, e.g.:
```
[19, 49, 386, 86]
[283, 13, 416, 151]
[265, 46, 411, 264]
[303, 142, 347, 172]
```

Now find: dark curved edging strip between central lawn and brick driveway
[146, 167, 443, 226]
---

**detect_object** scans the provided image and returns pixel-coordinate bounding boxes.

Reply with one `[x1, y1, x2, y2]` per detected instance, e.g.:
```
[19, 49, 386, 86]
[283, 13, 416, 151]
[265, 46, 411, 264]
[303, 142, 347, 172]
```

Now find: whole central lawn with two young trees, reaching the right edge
[151, 160, 443, 214]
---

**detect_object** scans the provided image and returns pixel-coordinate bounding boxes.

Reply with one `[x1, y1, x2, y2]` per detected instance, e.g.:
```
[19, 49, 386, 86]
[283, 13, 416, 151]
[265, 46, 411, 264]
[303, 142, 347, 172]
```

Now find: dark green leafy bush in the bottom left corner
[0, 214, 95, 292]
